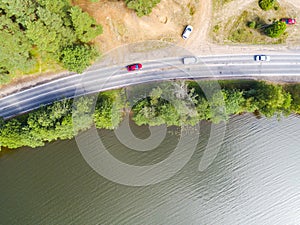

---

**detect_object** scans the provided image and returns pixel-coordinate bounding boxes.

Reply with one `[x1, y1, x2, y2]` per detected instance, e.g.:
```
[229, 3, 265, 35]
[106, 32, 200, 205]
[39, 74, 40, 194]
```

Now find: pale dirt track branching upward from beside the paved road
[179, 0, 300, 55]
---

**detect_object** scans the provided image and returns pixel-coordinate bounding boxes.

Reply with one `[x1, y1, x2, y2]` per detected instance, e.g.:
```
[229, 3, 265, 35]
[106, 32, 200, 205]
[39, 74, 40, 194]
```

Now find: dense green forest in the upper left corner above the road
[0, 0, 102, 84]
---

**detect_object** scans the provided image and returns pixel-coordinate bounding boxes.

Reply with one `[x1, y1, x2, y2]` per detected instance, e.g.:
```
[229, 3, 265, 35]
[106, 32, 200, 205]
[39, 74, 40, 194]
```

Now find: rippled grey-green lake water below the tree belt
[0, 114, 300, 225]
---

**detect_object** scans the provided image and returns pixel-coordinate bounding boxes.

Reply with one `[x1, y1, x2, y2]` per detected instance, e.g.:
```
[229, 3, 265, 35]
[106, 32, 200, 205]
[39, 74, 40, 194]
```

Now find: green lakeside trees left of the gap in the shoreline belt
[0, 90, 124, 150]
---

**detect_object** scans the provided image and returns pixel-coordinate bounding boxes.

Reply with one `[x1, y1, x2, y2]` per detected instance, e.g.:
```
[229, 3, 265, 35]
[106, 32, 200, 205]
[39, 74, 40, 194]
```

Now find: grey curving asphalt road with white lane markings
[0, 53, 300, 119]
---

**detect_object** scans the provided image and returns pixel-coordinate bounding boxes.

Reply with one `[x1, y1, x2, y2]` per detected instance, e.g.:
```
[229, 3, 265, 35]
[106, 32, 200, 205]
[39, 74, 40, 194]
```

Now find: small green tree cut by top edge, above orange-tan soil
[125, 0, 160, 17]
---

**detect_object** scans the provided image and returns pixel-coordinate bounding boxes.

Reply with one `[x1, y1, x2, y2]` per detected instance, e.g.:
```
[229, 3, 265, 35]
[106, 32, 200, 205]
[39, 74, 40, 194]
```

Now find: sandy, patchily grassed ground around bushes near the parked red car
[210, 0, 300, 45]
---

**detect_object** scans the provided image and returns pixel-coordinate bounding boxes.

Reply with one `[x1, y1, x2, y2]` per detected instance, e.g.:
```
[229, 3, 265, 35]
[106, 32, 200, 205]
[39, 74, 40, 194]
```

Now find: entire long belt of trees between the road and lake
[0, 81, 300, 149]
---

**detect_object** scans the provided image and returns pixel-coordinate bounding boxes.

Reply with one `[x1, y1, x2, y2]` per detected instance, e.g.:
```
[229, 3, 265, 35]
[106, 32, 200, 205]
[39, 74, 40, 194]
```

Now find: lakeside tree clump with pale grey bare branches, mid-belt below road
[133, 81, 199, 126]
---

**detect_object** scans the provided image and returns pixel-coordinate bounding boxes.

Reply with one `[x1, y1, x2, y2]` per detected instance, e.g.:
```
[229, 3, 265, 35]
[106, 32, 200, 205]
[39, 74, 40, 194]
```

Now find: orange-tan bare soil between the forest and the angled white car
[75, 0, 200, 52]
